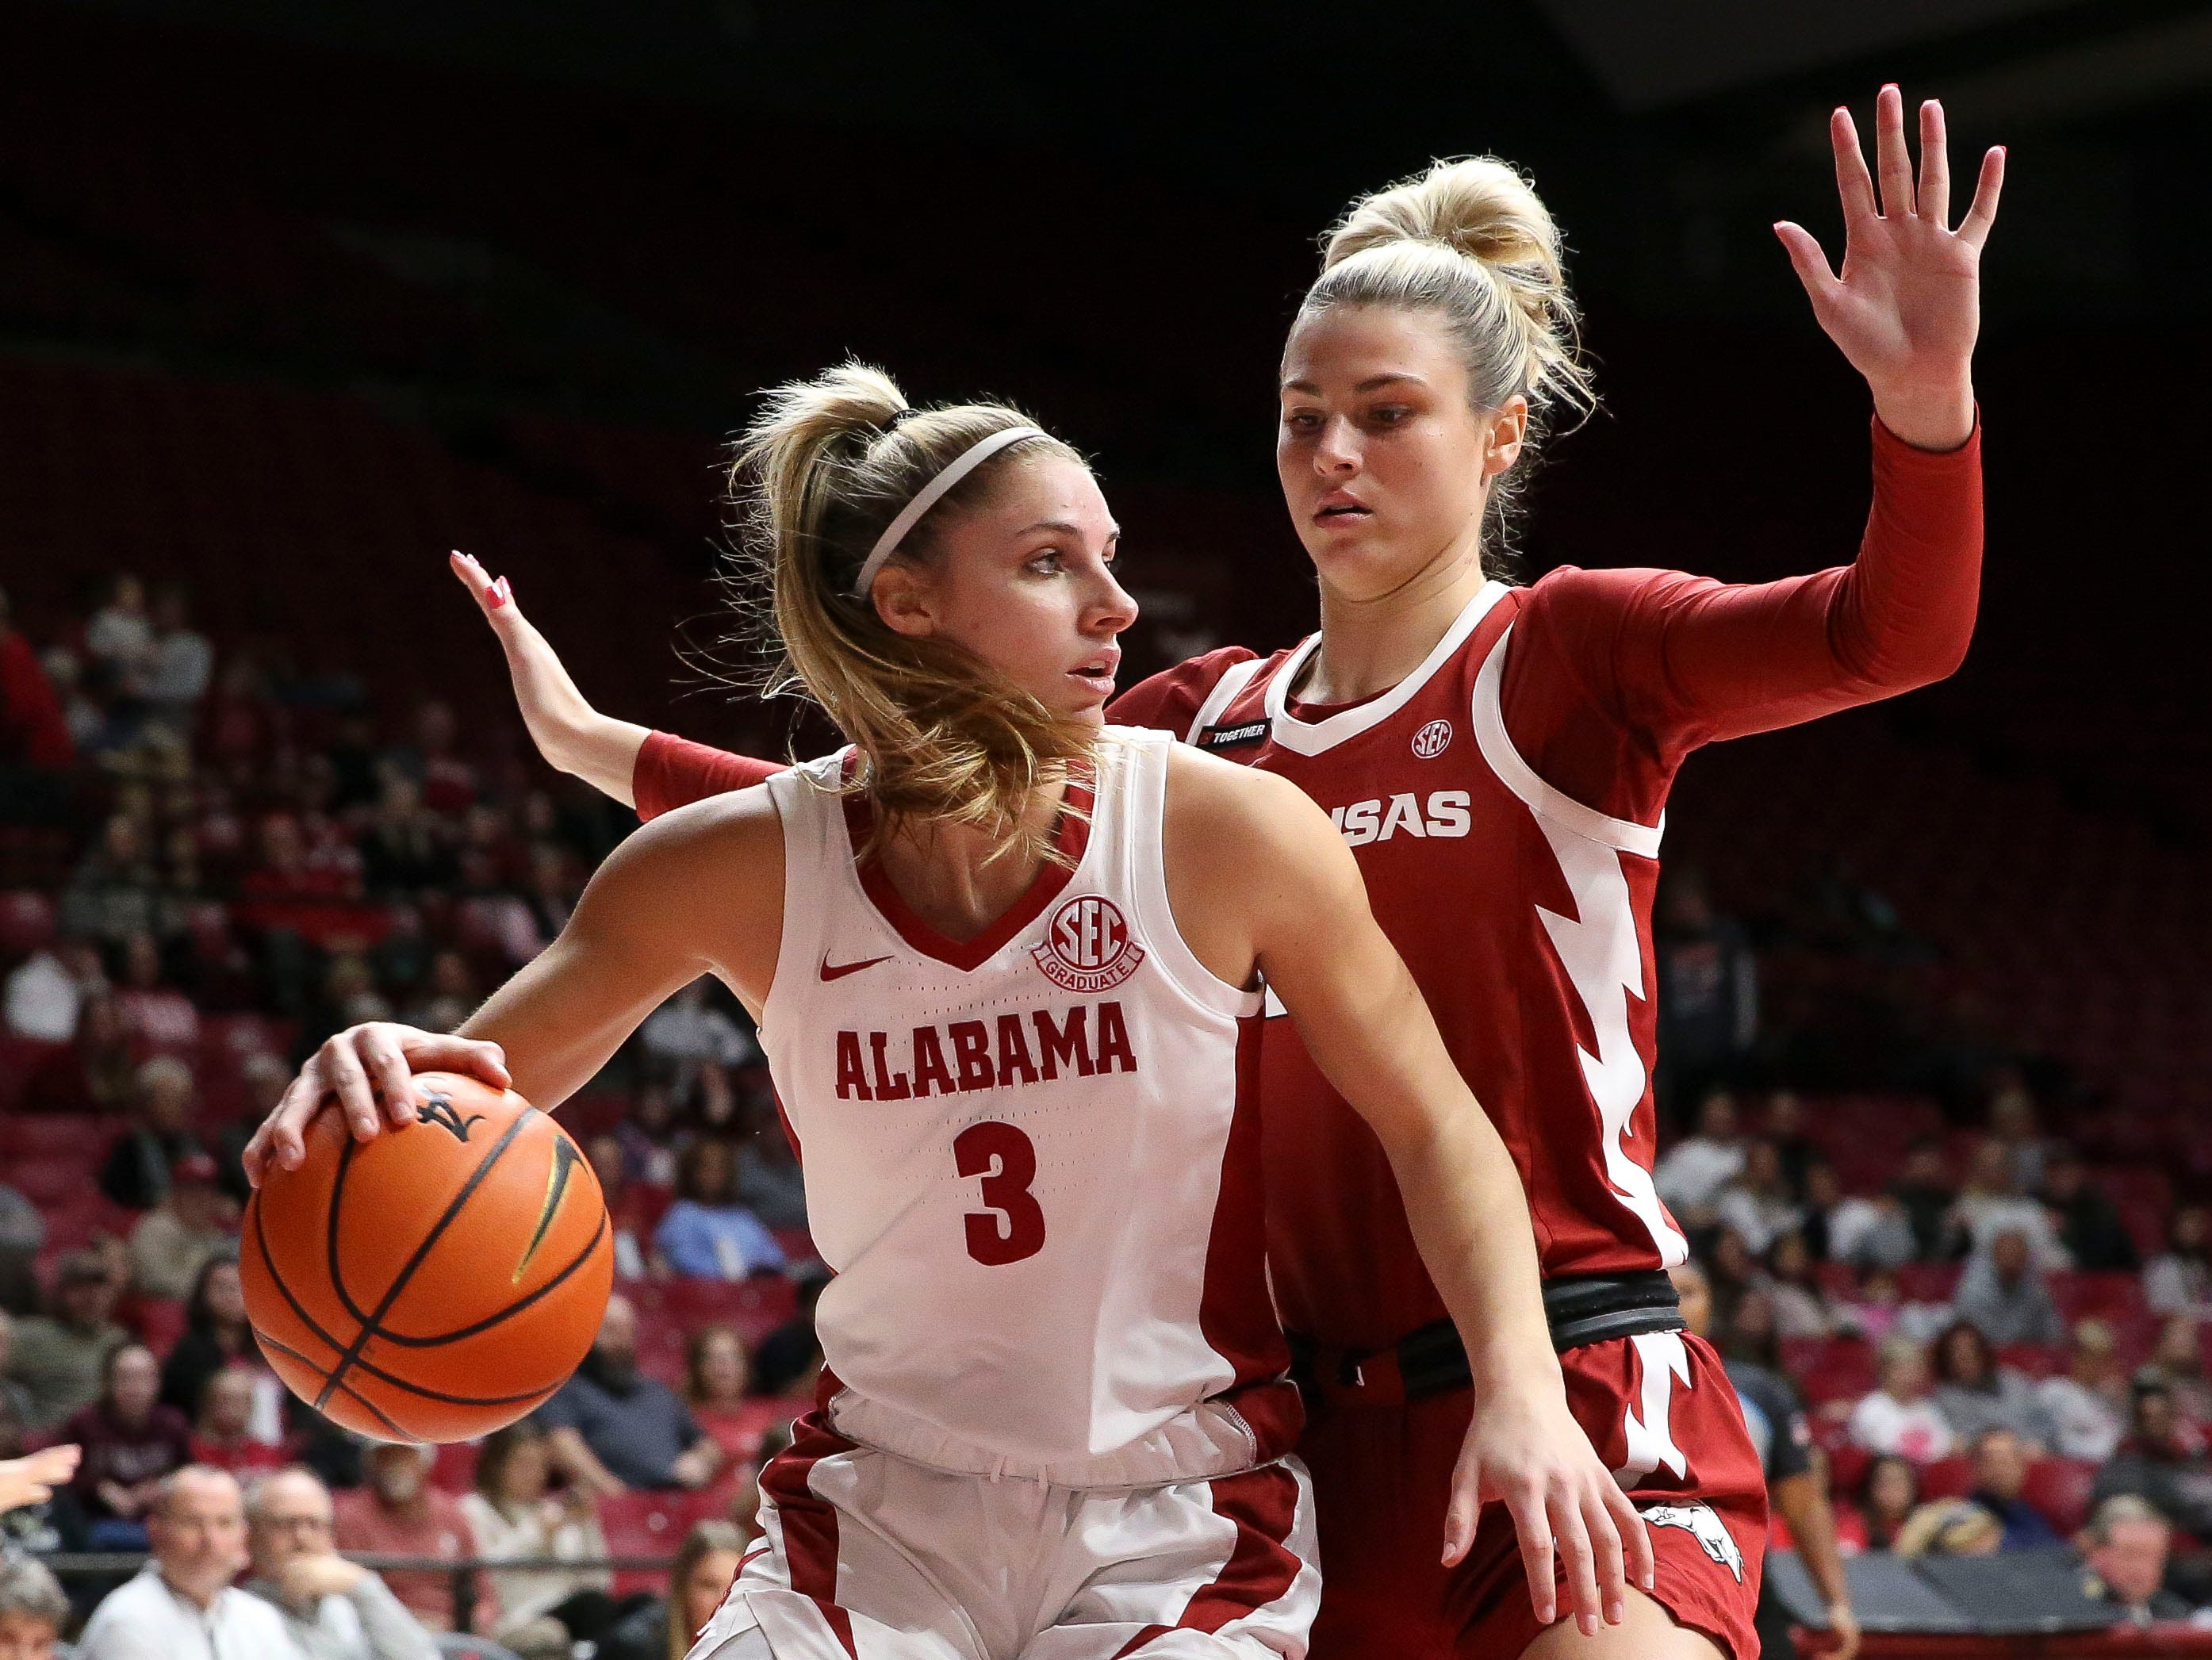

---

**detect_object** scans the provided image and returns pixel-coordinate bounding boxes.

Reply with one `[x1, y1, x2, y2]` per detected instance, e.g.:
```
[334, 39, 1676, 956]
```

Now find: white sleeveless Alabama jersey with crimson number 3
[761, 726, 1298, 1487]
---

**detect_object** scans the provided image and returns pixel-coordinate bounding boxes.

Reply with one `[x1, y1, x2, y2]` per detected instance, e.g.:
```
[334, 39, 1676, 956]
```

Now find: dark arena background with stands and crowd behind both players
[0, 0, 2212, 1660]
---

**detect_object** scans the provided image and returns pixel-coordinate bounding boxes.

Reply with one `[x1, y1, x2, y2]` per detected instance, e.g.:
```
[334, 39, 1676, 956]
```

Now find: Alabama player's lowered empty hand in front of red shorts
[1444, 1381, 1657, 1635]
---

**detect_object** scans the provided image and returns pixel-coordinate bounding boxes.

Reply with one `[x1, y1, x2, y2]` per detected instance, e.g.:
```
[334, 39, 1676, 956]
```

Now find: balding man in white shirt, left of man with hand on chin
[78, 1465, 301, 1660]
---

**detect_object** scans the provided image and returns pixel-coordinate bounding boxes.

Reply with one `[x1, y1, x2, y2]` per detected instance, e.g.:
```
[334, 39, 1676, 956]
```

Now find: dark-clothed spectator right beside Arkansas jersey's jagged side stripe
[1652, 865, 1758, 1114]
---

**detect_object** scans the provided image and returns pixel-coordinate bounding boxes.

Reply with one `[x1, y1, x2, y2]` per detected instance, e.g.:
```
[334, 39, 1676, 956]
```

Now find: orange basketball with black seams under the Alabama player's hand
[239, 1072, 615, 1441]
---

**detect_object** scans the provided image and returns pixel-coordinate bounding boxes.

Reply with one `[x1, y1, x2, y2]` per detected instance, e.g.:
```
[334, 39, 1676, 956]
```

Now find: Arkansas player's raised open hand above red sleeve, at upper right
[1774, 86, 2004, 450]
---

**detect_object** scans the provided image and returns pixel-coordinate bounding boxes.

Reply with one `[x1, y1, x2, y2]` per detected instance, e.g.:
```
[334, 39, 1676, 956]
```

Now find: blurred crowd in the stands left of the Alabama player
[0, 576, 821, 1660]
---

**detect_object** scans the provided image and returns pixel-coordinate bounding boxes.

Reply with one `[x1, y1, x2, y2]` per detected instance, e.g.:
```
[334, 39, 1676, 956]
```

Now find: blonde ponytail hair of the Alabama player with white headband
[730, 363, 1093, 872]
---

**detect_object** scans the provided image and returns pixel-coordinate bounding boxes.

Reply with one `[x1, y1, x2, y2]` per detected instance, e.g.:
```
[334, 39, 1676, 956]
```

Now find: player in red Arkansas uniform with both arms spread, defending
[458, 86, 2004, 1660]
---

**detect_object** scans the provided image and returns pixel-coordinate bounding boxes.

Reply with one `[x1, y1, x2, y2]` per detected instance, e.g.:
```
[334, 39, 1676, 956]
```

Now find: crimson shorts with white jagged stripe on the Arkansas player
[1298, 1332, 1767, 1660]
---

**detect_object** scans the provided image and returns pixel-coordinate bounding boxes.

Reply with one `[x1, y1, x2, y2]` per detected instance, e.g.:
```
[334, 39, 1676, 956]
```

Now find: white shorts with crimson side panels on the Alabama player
[690, 1412, 1321, 1660]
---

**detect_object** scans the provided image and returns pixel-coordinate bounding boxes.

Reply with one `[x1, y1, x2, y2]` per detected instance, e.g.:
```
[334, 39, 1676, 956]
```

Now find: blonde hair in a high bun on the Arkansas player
[1298, 155, 1597, 566]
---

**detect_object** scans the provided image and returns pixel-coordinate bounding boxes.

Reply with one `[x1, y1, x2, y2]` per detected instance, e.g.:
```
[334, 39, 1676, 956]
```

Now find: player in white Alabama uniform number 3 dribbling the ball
[247, 367, 1650, 1660]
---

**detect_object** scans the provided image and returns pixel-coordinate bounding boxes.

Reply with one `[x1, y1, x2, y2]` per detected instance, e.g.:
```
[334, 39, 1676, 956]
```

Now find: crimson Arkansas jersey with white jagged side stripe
[1115, 582, 1688, 1350]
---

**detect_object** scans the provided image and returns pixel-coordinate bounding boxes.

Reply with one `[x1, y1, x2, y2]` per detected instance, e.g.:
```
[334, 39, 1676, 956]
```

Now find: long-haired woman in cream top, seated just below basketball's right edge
[460, 1419, 634, 1655]
